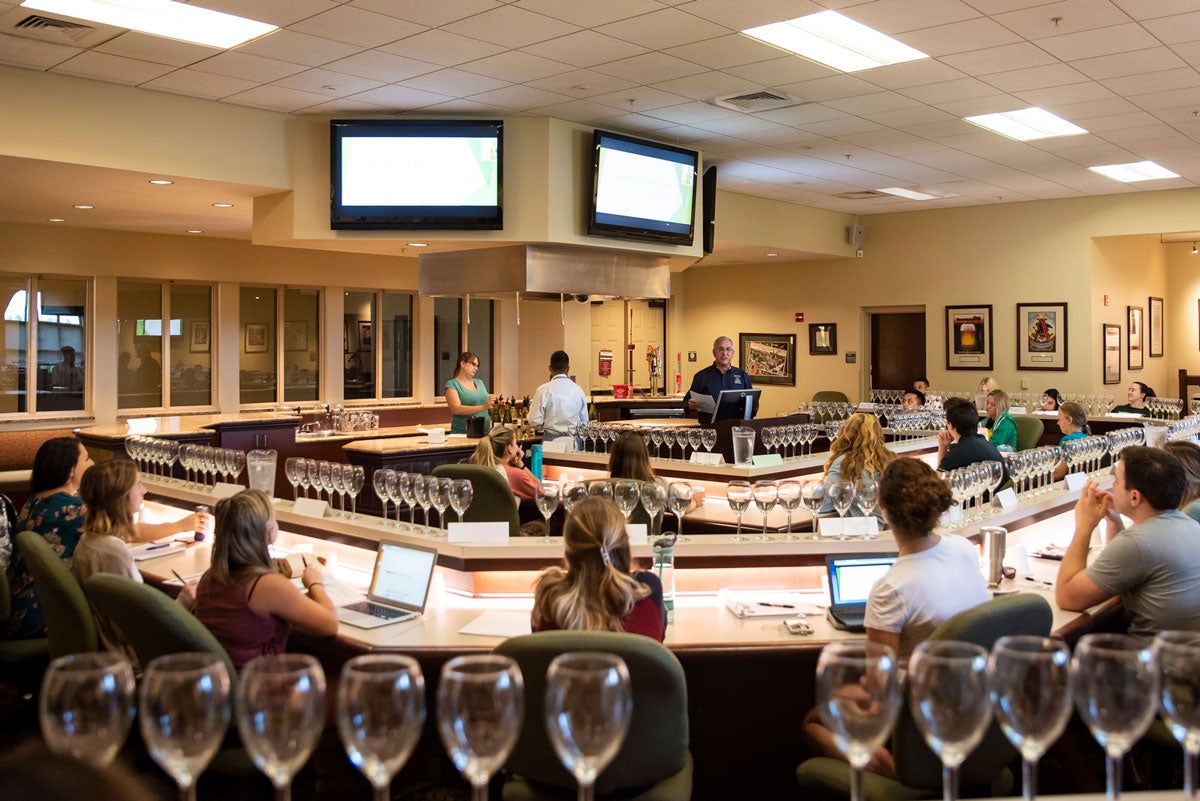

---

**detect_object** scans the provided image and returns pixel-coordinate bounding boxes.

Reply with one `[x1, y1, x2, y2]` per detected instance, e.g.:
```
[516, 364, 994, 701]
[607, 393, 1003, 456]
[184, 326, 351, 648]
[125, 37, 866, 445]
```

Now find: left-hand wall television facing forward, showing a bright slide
[329, 120, 504, 230]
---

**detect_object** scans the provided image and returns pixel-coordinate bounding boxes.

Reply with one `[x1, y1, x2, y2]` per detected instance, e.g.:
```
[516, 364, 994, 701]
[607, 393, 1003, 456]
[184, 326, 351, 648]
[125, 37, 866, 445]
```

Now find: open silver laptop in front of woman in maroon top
[337, 541, 438, 628]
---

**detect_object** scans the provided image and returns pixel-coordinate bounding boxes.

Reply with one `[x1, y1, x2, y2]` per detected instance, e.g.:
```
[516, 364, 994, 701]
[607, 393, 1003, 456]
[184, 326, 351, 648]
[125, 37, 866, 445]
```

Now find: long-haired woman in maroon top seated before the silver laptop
[192, 489, 337, 670]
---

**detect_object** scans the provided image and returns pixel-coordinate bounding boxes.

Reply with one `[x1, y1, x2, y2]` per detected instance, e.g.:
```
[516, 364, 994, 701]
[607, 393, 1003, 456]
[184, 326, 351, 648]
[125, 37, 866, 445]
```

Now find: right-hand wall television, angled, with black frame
[588, 131, 700, 245]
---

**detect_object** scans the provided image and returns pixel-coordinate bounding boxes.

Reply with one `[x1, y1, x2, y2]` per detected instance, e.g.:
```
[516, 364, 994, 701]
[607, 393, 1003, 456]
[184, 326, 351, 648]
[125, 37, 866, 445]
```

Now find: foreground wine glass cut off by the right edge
[1154, 631, 1200, 799]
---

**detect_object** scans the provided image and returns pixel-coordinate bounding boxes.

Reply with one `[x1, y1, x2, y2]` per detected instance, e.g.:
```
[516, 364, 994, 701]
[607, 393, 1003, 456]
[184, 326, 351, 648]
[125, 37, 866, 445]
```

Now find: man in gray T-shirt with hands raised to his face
[1055, 447, 1200, 636]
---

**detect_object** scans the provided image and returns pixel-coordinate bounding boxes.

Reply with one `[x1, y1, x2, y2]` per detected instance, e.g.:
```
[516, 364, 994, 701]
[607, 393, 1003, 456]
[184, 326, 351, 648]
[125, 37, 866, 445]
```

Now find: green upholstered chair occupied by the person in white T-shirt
[796, 592, 1052, 801]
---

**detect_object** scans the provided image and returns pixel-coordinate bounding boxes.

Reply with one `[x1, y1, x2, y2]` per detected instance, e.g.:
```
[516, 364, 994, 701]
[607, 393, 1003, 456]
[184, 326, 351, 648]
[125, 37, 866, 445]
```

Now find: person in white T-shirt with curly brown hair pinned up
[803, 455, 989, 777]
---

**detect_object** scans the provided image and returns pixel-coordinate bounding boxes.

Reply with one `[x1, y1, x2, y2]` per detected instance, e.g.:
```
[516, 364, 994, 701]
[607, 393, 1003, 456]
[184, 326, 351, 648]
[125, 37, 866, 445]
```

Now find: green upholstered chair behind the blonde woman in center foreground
[496, 631, 692, 801]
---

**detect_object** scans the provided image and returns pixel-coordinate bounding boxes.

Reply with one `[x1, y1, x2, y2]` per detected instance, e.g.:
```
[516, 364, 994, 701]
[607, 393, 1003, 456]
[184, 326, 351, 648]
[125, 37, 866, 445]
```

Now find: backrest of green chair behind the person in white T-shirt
[892, 592, 1052, 790]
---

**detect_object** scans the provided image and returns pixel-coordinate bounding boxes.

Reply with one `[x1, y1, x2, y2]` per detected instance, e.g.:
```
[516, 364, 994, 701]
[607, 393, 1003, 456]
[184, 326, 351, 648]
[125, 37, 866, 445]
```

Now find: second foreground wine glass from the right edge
[1070, 634, 1158, 801]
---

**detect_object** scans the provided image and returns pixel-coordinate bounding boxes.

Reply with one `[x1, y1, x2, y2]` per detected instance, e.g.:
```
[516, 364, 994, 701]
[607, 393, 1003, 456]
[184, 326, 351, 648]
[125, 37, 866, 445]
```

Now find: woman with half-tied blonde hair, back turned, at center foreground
[532, 498, 667, 642]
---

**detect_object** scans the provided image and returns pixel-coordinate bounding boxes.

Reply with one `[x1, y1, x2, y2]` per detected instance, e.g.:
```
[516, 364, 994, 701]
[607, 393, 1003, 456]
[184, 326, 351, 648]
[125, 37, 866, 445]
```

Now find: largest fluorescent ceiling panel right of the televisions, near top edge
[742, 11, 929, 72]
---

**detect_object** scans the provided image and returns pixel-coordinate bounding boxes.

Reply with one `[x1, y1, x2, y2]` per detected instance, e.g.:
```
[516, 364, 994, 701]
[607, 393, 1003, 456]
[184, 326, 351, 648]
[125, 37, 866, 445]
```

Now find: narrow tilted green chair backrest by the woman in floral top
[17, 531, 100, 660]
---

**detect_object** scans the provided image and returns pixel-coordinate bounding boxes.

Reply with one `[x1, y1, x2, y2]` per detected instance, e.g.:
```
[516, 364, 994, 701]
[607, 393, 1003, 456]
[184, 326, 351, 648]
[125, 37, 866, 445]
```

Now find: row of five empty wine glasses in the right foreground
[817, 632, 1200, 801]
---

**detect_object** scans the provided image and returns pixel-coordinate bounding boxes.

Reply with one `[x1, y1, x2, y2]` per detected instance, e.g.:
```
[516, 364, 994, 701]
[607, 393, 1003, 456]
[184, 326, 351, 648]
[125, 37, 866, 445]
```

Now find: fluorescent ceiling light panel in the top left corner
[20, 0, 278, 49]
